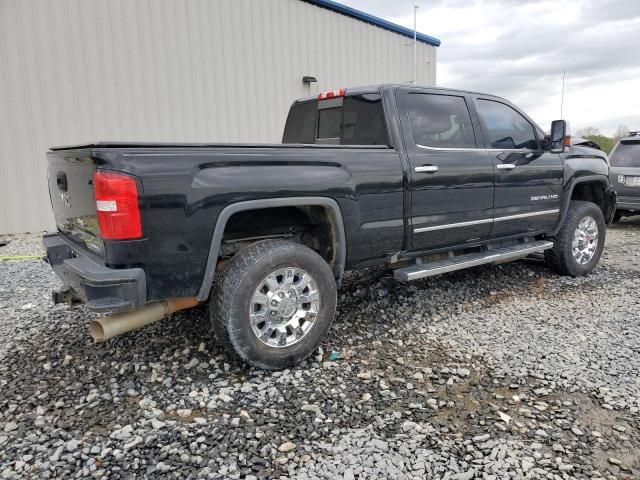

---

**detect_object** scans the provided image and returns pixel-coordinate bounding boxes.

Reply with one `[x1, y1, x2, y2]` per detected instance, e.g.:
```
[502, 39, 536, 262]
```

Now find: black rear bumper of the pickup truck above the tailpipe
[42, 233, 147, 312]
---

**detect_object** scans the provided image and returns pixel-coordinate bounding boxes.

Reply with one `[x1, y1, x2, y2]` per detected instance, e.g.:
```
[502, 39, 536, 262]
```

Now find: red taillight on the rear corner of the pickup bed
[93, 170, 142, 240]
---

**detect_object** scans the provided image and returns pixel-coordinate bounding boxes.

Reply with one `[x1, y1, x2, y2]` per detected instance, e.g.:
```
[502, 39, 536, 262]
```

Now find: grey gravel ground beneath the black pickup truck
[0, 217, 640, 480]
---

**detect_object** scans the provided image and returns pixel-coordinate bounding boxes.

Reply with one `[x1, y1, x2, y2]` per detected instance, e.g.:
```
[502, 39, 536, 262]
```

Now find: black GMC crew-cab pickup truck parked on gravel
[44, 85, 616, 368]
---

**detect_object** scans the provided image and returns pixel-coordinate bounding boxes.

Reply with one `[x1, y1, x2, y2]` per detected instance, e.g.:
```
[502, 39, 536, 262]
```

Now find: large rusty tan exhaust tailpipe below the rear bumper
[89, 297, 200, 342]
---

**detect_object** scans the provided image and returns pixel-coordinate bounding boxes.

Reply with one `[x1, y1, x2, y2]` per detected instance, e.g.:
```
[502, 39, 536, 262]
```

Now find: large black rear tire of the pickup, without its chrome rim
[209, 240, 337, 370]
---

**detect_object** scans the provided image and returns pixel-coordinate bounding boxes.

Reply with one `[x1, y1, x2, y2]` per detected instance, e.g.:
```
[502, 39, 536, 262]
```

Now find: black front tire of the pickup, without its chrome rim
[545, 200, 607, 277]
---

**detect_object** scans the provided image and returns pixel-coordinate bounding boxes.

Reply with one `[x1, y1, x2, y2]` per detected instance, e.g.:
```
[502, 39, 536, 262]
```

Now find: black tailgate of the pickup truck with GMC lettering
[47, 150, 104, 257]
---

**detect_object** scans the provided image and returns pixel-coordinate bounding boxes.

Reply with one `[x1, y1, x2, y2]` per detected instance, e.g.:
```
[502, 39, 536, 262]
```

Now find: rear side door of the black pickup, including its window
[397, 88, 494, 251]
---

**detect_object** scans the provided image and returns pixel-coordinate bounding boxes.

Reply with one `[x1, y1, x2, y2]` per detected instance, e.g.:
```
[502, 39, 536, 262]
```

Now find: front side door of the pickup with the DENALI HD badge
[475, 96, 564, 238]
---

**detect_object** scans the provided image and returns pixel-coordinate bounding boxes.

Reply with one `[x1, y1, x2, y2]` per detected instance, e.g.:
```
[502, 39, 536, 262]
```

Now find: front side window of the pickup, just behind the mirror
[478, 100, 538, 150]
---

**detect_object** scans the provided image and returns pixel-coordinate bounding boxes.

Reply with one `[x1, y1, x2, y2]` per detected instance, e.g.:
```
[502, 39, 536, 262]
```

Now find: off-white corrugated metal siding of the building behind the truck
[0, 0, 436, 234]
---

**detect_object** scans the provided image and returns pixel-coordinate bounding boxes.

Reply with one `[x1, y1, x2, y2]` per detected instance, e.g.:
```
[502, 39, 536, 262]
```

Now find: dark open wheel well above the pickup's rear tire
[217, 205, 338, 272]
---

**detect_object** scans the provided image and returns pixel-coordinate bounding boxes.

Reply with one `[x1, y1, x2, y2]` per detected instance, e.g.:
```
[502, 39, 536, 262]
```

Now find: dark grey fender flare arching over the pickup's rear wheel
[196, 197, 347, 302]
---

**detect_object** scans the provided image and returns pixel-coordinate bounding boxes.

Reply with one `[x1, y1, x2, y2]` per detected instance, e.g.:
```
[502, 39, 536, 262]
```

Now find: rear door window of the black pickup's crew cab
[408, 93, 476, 148]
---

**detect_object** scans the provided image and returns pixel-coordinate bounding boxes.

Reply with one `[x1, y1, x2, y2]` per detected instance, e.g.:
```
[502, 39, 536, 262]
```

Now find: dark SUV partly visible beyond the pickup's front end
[609, 132, 640, 222]
